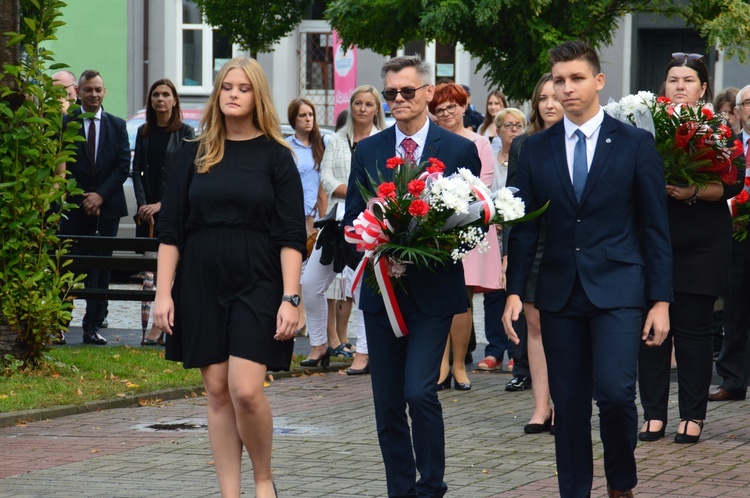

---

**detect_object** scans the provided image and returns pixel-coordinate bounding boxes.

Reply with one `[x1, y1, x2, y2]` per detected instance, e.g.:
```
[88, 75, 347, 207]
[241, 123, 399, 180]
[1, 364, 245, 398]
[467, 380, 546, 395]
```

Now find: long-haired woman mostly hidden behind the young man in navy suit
[505, 73, 564, 434]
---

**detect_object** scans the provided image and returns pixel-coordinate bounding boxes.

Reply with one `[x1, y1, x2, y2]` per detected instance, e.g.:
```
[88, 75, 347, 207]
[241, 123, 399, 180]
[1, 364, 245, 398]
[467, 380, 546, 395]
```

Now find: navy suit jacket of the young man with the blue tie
[507, 114, 672, 312]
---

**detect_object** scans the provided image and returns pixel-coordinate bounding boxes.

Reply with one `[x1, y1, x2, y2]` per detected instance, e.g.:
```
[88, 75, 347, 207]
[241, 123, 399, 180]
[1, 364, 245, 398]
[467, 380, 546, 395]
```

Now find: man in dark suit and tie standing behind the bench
[60, 70, 130, 345]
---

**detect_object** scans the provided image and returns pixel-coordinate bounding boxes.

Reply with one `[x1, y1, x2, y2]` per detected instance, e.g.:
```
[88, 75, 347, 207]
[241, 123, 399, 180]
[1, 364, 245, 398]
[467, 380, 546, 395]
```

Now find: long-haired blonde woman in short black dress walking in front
[154, 58, 307, 498]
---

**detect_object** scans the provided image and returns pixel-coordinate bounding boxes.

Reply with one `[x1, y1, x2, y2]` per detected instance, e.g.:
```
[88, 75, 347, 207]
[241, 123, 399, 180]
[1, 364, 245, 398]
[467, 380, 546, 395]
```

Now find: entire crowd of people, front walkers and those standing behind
[53, 42, 750, 497]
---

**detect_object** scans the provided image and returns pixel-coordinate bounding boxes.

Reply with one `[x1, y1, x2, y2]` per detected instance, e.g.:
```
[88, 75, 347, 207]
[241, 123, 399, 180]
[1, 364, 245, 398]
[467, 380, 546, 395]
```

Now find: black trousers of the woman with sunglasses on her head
[638, 292, 716, 423]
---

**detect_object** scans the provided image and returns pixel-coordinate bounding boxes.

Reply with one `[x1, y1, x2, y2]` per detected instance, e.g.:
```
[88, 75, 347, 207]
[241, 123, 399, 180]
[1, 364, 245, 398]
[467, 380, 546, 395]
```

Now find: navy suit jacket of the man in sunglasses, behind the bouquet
[343, 122, 482, 316]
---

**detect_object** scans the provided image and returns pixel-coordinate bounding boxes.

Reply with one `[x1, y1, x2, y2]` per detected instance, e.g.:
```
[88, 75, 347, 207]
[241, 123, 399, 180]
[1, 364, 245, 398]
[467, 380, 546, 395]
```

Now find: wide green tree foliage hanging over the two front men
[326, 0, 750, 99]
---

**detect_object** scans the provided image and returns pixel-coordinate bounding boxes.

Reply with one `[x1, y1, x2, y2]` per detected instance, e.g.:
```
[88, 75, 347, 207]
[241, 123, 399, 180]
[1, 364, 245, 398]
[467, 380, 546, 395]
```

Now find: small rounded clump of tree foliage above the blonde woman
[195, 0, 311, 52]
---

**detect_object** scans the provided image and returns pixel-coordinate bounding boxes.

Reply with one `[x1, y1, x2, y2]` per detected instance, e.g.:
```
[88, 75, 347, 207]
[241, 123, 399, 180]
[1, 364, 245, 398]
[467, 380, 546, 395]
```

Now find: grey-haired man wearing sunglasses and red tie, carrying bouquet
[343, 56, 481, 497]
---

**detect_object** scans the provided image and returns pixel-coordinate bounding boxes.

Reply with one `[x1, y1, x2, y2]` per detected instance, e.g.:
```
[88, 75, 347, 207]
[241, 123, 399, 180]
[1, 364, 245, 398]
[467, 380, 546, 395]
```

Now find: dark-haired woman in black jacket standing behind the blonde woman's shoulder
[133, 78, 195, 346]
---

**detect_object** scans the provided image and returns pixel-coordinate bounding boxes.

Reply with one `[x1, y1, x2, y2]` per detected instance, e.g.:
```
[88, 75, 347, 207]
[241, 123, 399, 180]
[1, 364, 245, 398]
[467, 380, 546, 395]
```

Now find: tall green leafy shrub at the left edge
[0, 0, 82, 364]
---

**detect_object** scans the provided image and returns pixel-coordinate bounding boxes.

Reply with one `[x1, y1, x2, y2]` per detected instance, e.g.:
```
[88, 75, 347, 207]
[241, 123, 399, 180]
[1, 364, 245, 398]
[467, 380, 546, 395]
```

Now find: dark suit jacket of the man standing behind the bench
[63, 108, 130, 220]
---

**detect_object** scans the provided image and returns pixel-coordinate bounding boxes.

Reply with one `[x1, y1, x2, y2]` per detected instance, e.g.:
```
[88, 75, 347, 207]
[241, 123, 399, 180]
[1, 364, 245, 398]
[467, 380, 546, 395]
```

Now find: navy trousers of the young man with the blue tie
[540, 281, 643, 498]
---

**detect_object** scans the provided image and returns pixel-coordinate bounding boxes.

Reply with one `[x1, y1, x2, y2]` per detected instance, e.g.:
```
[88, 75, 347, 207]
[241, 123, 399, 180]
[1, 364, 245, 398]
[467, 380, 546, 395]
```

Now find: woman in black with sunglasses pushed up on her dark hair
[638, 53, 745, 443]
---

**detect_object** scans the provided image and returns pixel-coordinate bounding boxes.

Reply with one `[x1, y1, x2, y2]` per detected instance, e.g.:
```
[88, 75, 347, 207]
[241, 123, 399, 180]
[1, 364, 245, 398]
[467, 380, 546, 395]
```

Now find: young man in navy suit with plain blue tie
[503, 41, 672, 498]
